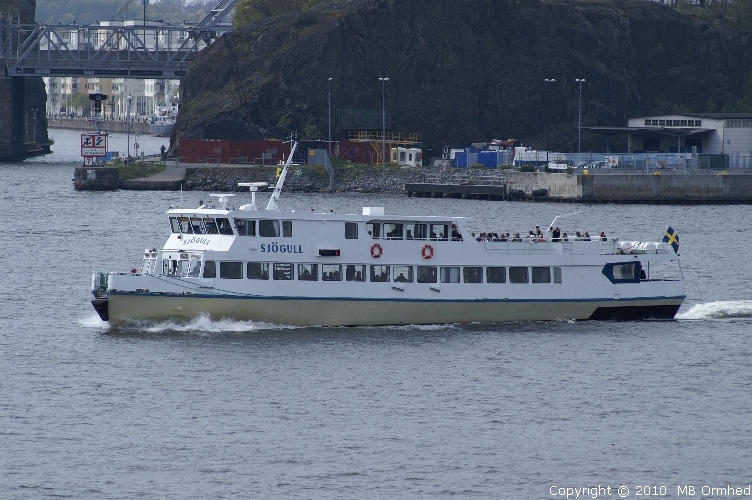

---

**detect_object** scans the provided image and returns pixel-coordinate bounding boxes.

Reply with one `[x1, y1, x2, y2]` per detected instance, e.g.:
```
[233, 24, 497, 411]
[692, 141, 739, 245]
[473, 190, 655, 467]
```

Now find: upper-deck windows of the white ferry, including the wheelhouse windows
[170, 217, 462, 241]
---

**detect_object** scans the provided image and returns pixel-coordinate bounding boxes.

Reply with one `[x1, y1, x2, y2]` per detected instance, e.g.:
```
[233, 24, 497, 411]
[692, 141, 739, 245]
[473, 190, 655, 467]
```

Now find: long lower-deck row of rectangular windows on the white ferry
[169, 259, 561, 283]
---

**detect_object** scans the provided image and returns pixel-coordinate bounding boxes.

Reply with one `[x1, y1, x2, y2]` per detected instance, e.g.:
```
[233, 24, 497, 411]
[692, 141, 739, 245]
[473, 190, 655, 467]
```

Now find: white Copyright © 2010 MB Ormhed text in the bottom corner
[548, 484, 752, 498]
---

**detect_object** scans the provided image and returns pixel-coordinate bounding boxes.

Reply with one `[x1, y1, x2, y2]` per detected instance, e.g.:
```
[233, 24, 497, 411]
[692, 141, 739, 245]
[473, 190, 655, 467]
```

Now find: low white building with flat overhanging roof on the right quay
[583, 113, 752, 155]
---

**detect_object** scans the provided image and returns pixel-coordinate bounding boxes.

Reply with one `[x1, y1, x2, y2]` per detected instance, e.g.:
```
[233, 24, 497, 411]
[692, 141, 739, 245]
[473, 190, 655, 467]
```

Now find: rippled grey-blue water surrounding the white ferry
[0, 130, 752, 499]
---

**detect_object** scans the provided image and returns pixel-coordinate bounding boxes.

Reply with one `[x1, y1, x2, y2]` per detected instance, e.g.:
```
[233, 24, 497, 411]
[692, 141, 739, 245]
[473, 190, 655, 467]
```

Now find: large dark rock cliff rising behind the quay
[173, 0, 752, 155]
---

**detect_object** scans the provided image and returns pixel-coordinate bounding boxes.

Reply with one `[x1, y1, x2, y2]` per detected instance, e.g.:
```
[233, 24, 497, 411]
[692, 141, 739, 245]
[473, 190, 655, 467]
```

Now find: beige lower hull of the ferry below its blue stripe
[101, 294, 683, 326]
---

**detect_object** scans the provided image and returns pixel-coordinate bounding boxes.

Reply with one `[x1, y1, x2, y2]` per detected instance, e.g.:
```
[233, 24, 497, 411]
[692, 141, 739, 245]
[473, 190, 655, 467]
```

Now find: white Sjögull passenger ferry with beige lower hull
[92, 146, 685, 326]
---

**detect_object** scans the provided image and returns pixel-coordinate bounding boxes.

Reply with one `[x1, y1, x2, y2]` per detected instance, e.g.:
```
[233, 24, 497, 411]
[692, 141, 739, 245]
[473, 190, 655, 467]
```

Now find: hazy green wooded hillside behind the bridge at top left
[36, 0, 218, 24]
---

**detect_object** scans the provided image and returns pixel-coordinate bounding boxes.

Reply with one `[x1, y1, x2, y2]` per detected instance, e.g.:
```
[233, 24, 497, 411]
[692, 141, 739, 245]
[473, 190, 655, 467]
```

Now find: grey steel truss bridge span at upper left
[0, 0, 235, 78]
